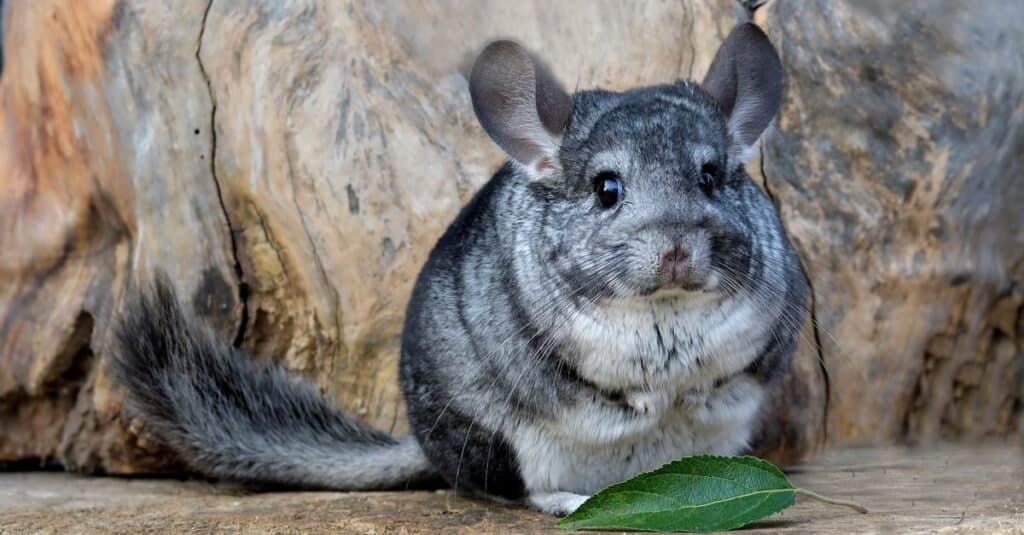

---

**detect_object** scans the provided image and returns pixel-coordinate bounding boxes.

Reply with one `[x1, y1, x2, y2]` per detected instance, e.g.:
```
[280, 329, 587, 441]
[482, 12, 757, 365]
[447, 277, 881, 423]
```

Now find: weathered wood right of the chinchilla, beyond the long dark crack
[756, 0, 1024, 443]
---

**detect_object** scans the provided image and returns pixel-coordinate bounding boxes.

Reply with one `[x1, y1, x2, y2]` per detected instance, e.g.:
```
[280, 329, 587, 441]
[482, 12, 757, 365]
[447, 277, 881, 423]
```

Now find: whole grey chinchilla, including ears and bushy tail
[110, 25, 805, 513]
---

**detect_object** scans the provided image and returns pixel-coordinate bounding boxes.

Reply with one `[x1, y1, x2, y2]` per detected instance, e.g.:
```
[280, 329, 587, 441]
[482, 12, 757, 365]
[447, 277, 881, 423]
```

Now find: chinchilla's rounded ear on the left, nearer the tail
[469, 41, 572, 178]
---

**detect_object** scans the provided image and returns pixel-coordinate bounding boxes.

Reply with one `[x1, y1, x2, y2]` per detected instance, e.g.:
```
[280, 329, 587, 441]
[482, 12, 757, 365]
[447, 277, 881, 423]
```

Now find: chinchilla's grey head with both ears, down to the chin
[470, 24, 782, 297]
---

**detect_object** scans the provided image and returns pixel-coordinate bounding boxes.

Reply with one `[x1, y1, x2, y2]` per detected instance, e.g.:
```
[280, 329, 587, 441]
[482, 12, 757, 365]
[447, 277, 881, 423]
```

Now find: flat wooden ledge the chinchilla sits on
[0, 445, 1024, 534]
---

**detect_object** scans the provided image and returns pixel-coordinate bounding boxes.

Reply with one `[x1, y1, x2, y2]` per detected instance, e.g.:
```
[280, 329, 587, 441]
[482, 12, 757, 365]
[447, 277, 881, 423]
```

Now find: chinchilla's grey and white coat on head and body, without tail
[401, 21, 805, 513]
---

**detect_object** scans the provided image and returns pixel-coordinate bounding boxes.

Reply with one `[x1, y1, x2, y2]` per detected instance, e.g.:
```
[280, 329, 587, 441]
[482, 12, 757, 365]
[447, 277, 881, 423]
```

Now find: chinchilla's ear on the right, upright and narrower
[700, 23, 782, 164]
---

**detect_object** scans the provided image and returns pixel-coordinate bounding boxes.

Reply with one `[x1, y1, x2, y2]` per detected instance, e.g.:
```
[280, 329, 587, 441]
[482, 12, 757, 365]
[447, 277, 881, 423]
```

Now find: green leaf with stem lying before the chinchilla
[558, 455, 797, 531]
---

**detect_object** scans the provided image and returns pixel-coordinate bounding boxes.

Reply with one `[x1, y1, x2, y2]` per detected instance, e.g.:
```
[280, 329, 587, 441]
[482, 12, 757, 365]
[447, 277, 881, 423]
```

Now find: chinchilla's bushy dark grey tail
[114, 274, 435, 490]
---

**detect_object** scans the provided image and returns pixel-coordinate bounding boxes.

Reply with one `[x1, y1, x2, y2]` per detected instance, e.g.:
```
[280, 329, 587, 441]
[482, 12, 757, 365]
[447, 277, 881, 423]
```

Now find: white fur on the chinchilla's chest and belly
[511, 291, 768, 494]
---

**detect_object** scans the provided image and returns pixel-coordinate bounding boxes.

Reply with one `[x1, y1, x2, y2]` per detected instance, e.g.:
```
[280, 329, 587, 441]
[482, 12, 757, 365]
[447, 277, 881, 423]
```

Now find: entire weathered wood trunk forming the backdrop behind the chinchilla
[0, 0, 1024, 472]
